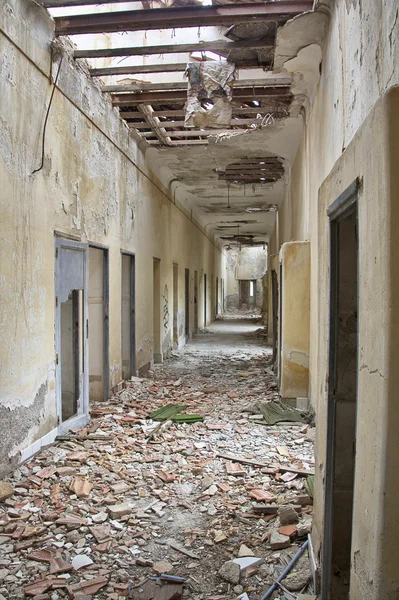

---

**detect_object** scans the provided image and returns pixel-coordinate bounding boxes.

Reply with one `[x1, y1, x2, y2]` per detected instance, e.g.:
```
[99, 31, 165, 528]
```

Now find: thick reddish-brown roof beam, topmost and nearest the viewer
[54, 0, 313, 35]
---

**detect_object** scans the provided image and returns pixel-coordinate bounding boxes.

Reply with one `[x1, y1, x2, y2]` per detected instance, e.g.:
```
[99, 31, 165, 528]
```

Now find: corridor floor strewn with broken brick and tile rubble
[0, 319, 314, 600]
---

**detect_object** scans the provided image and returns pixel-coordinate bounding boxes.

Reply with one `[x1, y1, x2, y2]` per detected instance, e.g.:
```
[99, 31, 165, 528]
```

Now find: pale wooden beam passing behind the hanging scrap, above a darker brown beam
[101, 73, 291, 93]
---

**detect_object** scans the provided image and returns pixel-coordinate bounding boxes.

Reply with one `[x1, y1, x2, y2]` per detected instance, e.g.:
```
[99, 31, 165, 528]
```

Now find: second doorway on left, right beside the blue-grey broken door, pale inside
[89, 245, 109, 402]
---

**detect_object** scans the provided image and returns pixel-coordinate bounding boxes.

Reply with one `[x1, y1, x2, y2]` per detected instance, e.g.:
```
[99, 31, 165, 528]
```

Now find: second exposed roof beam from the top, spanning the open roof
[73, 38, 274, 58]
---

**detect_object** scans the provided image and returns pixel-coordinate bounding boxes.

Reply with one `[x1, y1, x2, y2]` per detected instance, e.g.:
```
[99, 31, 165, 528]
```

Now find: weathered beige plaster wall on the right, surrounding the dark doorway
[271, 0, 399, 600]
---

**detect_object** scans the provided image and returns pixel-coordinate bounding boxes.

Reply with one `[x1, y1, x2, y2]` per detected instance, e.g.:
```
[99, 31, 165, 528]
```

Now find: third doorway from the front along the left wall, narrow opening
[121, 252, 136, 380]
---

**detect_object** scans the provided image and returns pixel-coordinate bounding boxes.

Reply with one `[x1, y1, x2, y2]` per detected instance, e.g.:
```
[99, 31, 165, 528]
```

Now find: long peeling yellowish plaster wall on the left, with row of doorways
[0, 0, 222, 472]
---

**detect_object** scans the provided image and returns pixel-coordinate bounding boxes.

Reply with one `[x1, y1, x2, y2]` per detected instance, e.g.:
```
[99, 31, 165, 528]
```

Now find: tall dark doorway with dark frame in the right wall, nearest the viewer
[322, 182, 358, 600]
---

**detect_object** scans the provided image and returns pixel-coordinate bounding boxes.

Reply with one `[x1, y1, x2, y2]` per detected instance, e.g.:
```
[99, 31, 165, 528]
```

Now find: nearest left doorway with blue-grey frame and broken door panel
[55, 238, 89, 432]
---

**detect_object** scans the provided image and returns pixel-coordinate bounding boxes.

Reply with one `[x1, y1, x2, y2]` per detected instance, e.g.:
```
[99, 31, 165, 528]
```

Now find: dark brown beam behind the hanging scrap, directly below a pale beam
[112, 86, 291, 106]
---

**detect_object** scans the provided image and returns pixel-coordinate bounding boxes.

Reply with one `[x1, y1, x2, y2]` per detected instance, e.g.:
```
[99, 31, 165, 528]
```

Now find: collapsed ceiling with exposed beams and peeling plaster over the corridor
[42, 0, 328, 247]
